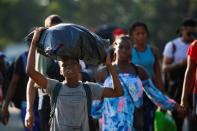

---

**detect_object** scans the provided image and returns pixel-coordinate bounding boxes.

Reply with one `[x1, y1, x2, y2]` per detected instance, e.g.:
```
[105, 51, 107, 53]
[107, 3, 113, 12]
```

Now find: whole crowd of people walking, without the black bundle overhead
[0, 15, 197, 131]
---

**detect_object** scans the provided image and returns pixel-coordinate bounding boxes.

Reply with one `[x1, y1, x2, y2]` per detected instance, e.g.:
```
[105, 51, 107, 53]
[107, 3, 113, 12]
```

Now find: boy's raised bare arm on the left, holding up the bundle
[26, 27, 47, 88]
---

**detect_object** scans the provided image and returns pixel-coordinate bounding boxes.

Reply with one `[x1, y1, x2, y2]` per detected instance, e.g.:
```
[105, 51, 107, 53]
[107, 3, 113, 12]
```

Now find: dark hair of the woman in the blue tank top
[129, 21, 149, 36]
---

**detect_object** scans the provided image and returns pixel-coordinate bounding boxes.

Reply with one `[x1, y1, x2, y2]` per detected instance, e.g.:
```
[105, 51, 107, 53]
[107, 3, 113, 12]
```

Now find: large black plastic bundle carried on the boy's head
[26, 23, 109, 65]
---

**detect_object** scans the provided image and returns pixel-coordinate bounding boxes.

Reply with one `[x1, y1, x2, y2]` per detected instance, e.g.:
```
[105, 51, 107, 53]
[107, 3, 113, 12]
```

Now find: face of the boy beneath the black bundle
[59, 59, 80, 79]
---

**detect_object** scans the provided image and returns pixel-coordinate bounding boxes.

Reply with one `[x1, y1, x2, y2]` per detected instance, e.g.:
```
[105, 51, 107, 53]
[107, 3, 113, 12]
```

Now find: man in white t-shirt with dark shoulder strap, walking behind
[162, 18, 197, 131]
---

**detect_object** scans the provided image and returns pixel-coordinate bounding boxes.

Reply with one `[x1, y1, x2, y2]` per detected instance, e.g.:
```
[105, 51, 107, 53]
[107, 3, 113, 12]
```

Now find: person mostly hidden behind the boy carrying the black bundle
[25, 14, 64, 131]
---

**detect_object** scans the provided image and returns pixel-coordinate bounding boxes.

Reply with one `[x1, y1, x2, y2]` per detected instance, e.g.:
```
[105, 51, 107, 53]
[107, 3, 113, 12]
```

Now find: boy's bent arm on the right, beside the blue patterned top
[102, 55, 124, 98]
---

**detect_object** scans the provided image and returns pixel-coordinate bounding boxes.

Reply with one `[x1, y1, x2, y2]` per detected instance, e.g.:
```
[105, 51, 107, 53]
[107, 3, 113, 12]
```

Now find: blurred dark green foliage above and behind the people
[0, 0, 197, 50]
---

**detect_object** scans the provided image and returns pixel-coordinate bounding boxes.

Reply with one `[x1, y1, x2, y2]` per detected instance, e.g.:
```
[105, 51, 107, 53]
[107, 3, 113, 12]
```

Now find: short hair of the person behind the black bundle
[45, 14, 63, 25]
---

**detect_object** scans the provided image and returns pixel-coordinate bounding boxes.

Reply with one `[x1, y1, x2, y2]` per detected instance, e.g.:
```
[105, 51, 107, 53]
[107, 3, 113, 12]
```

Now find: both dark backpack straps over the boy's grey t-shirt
[49, 83, 96, 131]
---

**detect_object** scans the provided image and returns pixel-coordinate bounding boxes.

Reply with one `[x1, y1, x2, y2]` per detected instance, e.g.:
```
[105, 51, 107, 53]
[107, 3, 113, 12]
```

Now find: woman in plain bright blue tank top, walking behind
[129, 21, 164, 131]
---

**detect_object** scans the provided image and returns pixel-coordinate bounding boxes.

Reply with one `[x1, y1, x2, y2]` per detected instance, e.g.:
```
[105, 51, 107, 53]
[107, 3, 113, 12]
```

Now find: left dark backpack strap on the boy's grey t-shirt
[49, 83, 62, 124]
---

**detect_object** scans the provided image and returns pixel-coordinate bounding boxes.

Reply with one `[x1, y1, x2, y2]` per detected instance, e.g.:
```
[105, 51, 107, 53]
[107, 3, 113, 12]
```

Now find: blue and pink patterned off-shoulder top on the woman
[92, 73, 175, 131]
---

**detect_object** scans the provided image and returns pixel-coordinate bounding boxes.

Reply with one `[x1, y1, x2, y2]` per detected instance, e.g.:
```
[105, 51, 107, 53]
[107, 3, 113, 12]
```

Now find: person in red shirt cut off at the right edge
[181, 40, 197, 131]
